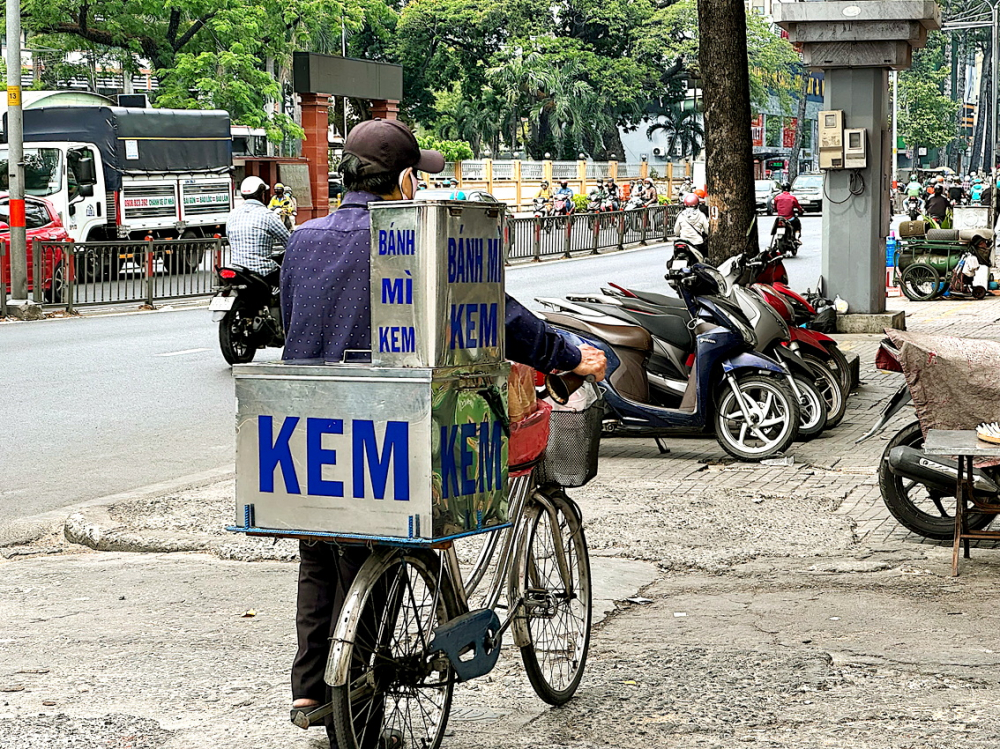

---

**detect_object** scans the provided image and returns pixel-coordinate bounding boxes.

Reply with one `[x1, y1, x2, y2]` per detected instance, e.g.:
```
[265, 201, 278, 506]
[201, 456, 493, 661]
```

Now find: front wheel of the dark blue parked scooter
[714, 374, 800, 462]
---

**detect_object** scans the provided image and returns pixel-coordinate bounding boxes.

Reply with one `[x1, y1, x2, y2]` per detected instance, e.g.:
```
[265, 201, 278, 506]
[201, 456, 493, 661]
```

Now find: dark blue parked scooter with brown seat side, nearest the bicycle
[538, 264, 800, 461]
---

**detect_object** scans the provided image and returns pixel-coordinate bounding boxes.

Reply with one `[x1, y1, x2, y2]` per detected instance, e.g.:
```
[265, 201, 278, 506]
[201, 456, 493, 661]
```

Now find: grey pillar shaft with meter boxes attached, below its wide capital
[822, 68, 892, 314]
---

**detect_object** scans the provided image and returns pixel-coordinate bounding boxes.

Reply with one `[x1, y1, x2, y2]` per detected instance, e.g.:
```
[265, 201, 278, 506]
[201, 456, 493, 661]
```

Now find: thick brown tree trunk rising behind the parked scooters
[698, 0, 758, 262]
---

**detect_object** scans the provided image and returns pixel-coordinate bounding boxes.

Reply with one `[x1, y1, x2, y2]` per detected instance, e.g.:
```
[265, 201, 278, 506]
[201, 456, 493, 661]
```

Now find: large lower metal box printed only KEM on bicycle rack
[229, 362, 510, 544]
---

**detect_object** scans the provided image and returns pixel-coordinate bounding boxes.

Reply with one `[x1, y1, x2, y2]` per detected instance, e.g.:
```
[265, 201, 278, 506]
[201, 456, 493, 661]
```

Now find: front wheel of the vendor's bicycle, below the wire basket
[510, 490, 592, 705]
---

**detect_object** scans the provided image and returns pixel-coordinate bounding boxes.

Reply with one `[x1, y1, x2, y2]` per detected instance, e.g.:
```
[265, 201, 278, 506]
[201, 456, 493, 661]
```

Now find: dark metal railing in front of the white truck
[34, 238, 229, 312]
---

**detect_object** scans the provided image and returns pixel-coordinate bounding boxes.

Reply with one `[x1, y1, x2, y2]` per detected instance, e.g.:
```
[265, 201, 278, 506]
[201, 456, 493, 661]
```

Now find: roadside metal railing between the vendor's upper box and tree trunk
[507, 205, 679, 262]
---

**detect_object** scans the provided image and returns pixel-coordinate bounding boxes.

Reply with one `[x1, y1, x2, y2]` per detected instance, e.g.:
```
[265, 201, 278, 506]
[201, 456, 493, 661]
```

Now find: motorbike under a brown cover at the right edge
[858, 339, 1000, 541]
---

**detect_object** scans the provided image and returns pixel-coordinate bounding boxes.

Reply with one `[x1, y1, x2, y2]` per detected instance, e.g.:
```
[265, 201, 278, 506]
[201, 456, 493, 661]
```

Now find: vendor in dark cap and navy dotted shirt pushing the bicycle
[282, 120, 605, 748]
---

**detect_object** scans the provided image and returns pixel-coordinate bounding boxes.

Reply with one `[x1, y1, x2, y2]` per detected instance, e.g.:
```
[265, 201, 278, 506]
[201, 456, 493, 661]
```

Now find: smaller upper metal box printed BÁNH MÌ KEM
[371, 200, 505, 367]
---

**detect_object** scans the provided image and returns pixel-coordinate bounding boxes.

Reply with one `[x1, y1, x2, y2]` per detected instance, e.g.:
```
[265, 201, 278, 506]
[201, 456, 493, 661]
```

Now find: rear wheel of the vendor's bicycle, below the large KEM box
[326, 550, 459, 749]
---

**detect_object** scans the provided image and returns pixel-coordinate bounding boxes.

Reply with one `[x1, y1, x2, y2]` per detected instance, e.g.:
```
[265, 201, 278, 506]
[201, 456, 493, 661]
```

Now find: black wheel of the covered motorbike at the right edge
[878, 421, 995, 541]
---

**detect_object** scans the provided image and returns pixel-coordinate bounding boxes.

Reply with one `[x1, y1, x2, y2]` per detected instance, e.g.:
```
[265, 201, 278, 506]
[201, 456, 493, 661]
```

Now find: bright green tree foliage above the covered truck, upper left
[22, 0, 358, 140]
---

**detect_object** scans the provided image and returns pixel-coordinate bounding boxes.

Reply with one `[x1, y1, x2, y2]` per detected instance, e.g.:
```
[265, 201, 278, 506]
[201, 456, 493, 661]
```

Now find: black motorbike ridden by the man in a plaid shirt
[208, 252, 285, 364]
